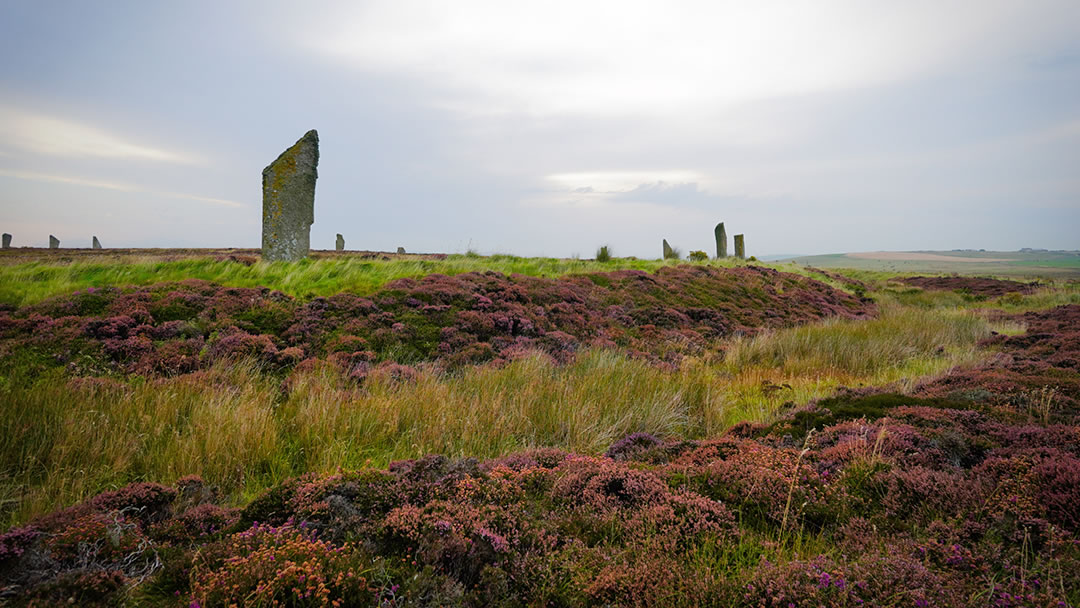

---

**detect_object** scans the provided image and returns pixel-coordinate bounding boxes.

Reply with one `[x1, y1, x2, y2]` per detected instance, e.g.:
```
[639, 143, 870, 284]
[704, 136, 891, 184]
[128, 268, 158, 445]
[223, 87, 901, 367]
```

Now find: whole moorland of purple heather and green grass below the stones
[0, 256, 1080, 607]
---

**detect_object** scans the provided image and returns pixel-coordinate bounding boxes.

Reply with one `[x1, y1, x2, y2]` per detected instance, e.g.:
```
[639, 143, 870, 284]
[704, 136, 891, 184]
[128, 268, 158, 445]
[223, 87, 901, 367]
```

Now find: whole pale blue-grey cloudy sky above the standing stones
[0, 0, 1080, 258]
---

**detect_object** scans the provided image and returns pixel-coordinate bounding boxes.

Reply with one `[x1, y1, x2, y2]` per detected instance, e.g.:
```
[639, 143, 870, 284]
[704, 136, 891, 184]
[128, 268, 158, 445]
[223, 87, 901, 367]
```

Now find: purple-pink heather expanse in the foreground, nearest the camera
[0, 307, 1080, 607]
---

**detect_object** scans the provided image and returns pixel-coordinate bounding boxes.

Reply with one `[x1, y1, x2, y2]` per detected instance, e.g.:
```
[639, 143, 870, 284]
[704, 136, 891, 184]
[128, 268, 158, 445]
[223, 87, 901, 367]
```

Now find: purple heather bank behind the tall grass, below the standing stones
[0, 267, 874, 381]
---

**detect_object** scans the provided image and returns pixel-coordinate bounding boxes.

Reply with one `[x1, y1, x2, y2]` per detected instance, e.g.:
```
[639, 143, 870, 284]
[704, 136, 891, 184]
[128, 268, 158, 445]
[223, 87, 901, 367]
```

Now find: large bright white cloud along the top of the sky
[299, 0, 1076, 116]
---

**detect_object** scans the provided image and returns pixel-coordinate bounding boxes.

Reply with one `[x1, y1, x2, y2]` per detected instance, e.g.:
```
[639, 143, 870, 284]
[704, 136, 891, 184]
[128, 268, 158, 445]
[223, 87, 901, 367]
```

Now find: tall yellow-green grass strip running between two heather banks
[0, 305, 990, 522]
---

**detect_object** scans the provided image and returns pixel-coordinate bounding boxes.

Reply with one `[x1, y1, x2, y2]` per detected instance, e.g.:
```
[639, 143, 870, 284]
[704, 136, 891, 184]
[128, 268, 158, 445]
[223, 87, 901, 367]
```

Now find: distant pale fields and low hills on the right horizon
[784, 249, 1080, 279]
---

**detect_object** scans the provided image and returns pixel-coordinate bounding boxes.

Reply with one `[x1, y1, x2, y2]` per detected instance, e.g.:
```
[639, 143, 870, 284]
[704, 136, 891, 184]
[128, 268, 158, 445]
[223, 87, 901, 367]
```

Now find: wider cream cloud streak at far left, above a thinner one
[0, 107, 199, 164]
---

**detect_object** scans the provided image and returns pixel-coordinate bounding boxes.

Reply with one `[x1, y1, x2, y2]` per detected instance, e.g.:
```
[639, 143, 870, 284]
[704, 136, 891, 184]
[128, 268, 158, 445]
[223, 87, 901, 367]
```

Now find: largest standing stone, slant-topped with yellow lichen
[262, 130, 319, 261]
